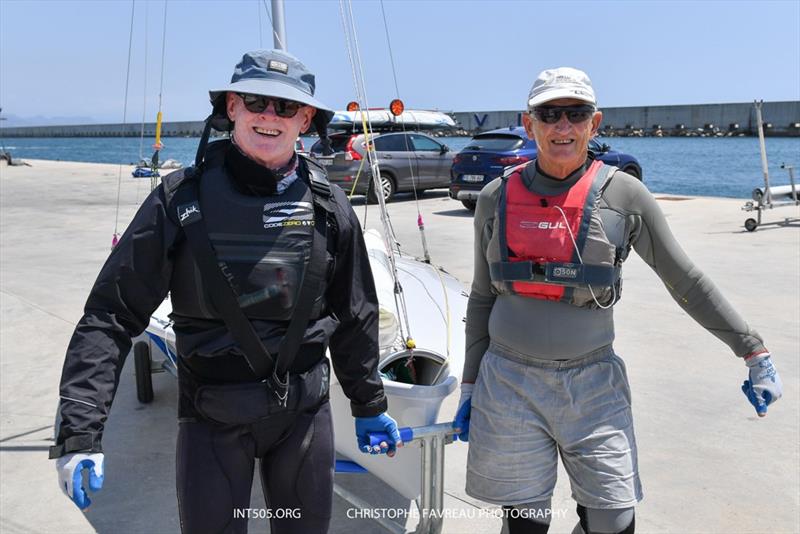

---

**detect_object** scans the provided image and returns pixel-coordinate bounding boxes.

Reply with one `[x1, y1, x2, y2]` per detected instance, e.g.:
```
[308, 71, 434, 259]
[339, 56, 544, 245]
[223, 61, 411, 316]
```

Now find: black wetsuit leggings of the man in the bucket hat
[177, 402, 334, 534]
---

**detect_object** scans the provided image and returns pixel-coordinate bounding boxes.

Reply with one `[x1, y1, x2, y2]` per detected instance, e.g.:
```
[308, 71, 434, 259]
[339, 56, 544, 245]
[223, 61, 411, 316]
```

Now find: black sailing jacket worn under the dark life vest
[51, 141, 387, 456]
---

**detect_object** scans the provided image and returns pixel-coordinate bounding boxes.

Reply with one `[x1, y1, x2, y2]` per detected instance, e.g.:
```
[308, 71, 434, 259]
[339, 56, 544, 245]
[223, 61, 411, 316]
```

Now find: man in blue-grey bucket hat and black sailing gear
[50, 50, 402, 534]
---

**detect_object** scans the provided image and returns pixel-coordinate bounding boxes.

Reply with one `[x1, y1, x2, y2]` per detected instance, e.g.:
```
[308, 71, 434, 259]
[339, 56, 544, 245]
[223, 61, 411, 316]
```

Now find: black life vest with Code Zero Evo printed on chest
[165, 141, 333, 321]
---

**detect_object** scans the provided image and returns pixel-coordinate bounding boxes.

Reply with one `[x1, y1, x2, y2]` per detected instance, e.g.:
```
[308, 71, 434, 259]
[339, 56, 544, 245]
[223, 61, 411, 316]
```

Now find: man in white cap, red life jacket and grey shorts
[454, 67, 782, 534]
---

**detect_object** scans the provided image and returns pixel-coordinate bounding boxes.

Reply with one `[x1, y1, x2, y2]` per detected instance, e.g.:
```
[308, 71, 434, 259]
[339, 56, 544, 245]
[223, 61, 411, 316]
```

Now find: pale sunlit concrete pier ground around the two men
[0, 161, 800, 534]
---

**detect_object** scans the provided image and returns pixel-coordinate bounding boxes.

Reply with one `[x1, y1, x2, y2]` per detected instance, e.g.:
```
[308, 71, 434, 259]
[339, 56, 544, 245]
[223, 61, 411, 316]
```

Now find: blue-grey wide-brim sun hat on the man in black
[208, 50, 334, 130]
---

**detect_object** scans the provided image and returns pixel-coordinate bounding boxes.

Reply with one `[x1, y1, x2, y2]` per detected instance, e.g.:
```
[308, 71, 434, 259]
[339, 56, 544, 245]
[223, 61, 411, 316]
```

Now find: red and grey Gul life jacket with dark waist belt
[490, 160, 620, 305]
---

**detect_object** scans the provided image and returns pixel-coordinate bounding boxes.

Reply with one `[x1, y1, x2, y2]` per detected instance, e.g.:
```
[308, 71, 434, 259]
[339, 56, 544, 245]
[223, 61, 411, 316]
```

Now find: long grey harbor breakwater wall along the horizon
[0, 101, 800, 138]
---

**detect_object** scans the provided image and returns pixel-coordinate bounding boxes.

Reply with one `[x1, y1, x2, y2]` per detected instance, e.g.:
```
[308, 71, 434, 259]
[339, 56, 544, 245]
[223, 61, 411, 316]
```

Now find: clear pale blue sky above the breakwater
[0, 0, 800, 125]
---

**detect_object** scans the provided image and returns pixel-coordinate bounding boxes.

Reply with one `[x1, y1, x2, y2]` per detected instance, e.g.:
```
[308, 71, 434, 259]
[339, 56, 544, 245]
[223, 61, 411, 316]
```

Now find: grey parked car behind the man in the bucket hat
[310, 132, 453, 202]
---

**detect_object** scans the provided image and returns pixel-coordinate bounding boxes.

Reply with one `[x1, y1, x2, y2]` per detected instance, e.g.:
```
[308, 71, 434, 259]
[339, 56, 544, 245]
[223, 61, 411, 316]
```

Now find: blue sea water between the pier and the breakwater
[0, 137, 800, 199]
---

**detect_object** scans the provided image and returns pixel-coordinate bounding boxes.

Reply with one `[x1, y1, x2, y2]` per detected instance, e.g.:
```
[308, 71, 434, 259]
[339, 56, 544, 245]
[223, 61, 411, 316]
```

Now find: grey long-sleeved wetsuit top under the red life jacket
[463, 160, 766, 382]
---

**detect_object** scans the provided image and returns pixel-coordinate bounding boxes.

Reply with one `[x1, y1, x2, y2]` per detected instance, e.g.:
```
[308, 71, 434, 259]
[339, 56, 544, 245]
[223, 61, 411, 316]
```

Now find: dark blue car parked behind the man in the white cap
[450, 126, 642, 210]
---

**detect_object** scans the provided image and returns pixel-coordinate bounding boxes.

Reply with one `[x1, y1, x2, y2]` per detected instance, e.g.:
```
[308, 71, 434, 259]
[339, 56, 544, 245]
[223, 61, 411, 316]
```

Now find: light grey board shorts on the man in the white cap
[466, 344, 642, 509]
